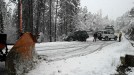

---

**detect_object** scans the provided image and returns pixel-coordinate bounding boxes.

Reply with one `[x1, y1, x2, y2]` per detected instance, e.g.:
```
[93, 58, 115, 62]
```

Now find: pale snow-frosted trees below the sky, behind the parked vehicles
[75, 7, 115, 31]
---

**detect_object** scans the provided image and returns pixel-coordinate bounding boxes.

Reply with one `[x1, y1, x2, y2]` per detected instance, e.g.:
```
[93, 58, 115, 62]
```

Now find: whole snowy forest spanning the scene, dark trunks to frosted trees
[0, 0, 134, 43]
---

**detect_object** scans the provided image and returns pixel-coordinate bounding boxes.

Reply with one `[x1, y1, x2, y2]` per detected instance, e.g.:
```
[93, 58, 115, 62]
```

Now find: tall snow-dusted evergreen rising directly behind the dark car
[59, 0, 79, 35]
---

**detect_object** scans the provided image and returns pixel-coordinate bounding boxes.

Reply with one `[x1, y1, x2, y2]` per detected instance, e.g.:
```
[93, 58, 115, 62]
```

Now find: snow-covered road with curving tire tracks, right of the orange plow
[36, 38, 116, 61]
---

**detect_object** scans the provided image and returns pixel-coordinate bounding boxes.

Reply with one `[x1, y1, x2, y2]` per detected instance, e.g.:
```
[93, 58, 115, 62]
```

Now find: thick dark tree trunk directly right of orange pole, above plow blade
[23, 0, 33, 33]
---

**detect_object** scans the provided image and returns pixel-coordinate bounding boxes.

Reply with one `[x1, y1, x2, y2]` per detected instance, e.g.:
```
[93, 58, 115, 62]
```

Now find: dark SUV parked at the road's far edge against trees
[64, 31, 89, 41]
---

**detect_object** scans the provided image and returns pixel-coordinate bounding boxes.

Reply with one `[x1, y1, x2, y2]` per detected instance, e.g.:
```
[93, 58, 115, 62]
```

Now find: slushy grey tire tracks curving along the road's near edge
[38, 41, 115, 62]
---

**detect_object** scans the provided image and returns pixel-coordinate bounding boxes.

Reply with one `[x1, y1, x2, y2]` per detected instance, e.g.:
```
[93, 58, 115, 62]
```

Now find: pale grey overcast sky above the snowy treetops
[81, 0, 134, 19]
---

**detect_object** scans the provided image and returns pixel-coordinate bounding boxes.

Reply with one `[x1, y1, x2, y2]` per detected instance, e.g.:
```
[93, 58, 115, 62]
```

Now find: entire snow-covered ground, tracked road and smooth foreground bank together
[0, 38, 134, 75]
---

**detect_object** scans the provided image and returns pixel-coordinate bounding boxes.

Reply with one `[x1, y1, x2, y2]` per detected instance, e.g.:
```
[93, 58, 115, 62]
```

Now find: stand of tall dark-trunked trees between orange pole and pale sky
[13, 0, 80, 41]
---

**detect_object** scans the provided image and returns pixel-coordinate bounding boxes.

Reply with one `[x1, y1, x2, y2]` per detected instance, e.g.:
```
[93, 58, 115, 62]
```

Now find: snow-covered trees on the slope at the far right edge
[116, 7, 134, 40]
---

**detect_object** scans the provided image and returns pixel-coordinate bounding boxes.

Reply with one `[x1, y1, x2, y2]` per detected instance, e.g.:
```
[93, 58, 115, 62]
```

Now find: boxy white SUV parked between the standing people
[97, 30, 118, 40]
